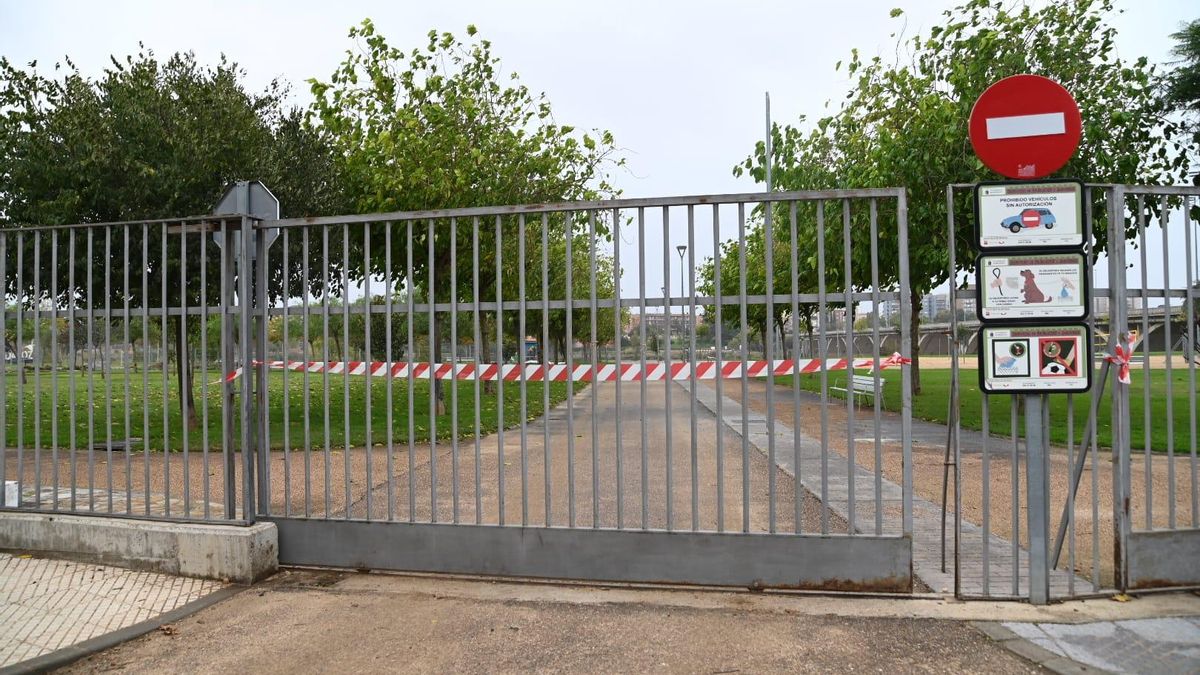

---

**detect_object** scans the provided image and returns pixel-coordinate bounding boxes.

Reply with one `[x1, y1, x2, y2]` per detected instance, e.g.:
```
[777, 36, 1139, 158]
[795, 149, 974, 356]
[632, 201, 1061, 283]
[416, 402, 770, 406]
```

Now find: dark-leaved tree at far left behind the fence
[0, 52, 341, 425]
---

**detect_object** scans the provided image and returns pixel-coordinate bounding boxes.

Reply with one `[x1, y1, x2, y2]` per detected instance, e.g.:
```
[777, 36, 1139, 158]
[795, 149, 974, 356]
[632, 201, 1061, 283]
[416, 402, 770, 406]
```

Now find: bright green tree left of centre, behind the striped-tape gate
[310, 19, 620, 410]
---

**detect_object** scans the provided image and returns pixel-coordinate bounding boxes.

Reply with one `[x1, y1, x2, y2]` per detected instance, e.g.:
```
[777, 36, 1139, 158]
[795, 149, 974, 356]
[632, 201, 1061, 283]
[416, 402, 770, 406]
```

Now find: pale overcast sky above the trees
[0, 0, 1200, 300]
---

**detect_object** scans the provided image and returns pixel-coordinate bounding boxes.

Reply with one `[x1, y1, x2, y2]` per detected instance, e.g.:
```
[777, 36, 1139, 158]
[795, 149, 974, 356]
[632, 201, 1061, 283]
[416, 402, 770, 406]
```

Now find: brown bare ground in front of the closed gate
[60, 572, 1037, 674]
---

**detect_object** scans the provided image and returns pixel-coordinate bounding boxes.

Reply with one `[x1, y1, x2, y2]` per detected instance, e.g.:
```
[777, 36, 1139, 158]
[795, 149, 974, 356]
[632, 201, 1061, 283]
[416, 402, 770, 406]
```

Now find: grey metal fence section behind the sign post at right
[943, 185, 1200, 598]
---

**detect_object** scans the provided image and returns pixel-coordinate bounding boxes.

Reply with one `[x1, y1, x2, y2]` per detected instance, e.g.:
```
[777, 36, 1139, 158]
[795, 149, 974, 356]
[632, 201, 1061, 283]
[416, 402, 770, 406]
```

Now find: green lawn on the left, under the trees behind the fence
[4, 370, 586, 450]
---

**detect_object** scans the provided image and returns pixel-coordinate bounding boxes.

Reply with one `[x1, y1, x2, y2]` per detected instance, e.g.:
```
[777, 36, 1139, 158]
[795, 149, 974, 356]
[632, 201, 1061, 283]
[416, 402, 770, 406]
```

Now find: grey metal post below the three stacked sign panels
[1025, 394, 1050, 604]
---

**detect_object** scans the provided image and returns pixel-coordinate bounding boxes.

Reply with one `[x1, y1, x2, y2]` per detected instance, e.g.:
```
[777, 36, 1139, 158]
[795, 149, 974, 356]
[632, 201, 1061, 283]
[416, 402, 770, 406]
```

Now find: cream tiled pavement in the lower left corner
[0, 554, 223, 668]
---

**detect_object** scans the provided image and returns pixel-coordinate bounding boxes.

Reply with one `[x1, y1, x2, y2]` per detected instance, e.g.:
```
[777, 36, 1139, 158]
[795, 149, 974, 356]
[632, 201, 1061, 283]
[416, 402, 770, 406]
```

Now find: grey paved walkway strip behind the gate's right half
[685, 383, 1092, 597]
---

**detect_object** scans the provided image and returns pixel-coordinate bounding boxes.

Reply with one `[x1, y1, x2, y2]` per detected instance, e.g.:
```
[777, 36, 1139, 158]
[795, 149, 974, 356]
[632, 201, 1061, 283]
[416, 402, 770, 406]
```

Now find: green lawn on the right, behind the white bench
[776, 368, 1200, 453]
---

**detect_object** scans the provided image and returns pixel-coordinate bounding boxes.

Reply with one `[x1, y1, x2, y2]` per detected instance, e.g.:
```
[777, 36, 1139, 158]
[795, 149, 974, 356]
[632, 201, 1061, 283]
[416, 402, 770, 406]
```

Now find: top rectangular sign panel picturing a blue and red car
[976, 180, 1086, 251]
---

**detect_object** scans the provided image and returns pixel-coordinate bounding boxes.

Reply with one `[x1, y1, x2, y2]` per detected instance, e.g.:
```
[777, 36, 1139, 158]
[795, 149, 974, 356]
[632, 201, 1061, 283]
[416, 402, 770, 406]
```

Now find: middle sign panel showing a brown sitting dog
[976, 253, 1088, 322]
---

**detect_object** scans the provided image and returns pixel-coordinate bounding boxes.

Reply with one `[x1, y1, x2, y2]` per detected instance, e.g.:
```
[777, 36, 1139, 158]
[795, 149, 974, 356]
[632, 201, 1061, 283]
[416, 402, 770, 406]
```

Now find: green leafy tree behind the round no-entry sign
[734, 0, 1186, 392]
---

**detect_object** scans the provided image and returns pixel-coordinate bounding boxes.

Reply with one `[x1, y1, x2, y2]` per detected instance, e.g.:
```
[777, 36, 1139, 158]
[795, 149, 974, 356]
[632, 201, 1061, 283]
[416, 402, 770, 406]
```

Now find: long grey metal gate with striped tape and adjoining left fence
[0, 189, 913, 592]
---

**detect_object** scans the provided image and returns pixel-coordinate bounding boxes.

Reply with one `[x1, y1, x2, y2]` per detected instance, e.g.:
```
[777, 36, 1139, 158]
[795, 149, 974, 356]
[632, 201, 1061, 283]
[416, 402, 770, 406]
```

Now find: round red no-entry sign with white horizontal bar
[968, 74, 1084, 178]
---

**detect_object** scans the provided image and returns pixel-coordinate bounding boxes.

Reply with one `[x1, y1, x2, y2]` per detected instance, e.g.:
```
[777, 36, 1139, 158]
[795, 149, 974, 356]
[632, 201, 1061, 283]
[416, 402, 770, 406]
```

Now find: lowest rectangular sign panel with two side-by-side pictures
[979, 324, 1092, 394]
